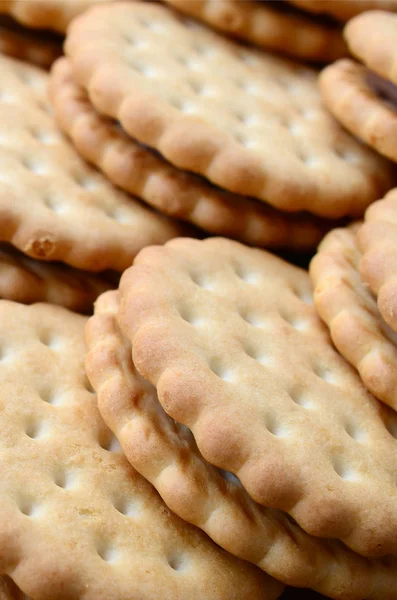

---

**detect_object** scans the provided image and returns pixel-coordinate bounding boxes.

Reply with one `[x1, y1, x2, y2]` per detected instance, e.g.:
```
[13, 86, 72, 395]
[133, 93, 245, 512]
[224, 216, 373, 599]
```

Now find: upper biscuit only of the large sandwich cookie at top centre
[65, 2, 396, 218]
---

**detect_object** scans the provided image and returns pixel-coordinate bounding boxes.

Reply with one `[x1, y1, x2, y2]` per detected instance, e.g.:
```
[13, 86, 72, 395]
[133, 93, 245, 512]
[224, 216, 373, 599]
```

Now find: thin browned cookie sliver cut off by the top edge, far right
[289, 0, 397, 21]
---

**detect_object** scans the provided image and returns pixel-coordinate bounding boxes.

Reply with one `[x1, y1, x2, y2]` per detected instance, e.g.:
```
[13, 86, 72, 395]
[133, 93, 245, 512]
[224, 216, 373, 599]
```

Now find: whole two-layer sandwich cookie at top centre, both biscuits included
[59, 2, 395, 249]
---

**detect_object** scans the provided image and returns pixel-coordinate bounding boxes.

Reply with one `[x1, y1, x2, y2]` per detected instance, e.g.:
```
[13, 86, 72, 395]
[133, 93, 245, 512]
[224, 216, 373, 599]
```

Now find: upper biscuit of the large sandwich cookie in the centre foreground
[120, 238, 397, 555]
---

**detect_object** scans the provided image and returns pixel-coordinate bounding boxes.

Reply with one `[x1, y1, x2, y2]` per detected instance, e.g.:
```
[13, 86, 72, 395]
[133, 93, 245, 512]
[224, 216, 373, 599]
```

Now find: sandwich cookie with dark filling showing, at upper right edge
[320, 11, 397, 162]
